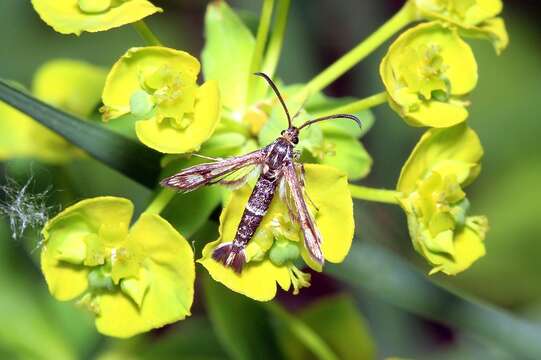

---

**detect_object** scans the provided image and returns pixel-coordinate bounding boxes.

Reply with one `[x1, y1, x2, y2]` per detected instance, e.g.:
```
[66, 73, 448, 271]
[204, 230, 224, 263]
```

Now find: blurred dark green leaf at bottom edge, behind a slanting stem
[279, 295, 375, 360]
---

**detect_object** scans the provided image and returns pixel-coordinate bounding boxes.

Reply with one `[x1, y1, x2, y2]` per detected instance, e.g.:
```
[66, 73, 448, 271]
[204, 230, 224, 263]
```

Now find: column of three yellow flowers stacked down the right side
[380, 0, 509, 275]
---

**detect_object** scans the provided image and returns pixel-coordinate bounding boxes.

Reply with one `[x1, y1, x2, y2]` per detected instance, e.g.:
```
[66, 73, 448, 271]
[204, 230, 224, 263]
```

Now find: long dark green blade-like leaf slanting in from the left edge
[0, 80, 161, 187]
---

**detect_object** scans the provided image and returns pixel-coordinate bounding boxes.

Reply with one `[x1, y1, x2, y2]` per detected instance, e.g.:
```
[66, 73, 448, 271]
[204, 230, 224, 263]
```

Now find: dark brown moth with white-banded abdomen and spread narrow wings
[160, 72, 361, 274]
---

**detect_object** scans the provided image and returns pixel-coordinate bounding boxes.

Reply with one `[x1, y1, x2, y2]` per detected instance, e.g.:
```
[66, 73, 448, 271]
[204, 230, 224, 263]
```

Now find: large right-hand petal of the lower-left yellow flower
[96, 213, 195, 337]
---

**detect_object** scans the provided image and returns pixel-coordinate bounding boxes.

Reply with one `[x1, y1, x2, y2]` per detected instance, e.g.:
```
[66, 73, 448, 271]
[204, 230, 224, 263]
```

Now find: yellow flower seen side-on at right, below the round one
[397, 124, 488, 275]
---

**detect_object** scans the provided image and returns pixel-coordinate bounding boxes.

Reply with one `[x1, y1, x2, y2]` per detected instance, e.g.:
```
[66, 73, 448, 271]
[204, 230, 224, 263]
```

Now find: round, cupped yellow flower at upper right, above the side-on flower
[380, 22, 477, 127]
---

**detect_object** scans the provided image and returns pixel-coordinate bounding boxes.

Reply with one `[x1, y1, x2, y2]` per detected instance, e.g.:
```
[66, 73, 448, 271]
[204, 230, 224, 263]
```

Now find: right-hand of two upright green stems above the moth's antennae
[262, 0, 291, 78]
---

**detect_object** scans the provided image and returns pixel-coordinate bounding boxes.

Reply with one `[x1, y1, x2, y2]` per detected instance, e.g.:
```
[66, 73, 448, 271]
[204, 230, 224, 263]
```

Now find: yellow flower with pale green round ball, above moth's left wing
[102, 47, 220, 154]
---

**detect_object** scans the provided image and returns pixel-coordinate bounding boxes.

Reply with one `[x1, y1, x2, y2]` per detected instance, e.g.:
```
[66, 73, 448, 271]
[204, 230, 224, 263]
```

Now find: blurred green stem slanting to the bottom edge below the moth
[264, 302, 338, 360]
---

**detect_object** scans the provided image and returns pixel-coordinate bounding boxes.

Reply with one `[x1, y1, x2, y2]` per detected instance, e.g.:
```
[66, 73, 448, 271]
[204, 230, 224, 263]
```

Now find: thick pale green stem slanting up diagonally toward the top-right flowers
[303, 1, 415, 97]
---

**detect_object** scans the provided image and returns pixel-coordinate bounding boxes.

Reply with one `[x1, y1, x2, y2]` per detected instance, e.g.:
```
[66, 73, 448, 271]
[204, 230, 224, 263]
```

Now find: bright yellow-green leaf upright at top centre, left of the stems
[202, 1, 255, 110]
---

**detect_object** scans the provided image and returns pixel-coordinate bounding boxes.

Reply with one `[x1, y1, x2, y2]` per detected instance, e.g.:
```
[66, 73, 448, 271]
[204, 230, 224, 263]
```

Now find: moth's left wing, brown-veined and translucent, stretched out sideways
[160, 148, 266, 191]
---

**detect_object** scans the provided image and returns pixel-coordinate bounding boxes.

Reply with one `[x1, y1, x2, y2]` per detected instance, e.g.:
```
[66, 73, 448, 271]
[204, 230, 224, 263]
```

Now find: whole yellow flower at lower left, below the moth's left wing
[41, 197, 195, 337]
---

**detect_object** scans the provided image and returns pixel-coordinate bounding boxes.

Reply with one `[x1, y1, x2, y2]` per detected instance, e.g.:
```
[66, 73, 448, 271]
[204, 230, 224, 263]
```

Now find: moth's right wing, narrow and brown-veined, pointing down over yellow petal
[283, 163, 325, 265]
